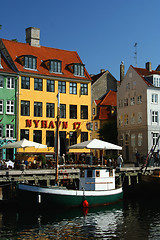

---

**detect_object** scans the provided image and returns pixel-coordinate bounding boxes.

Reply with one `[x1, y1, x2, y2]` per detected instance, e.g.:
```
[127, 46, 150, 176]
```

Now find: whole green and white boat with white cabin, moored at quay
[18, 167, 123, 208]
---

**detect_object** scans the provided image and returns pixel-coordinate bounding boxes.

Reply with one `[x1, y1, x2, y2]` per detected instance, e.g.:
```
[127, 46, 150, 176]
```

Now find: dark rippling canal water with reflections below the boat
[0, 198, 160, 240]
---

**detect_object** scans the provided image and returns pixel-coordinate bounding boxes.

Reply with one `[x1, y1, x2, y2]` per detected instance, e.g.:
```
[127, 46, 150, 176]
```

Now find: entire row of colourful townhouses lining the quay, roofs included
[0, 28, 160, 165]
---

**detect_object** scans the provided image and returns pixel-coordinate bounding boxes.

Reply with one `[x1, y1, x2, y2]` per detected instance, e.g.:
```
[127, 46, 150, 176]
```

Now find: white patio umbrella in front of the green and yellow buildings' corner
[0, 138, 47, 149]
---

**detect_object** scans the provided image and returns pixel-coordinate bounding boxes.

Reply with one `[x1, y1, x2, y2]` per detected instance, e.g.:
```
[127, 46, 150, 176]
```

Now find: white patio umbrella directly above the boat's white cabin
[69, 138, 122, 150]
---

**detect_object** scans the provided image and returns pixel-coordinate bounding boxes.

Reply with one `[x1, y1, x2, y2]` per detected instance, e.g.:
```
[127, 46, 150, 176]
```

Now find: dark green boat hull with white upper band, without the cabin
[18, 184, 123, 208]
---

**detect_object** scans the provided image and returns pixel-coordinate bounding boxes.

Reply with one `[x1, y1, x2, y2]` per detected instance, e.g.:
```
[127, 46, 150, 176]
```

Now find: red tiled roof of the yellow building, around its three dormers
[2, 39, 91, 80]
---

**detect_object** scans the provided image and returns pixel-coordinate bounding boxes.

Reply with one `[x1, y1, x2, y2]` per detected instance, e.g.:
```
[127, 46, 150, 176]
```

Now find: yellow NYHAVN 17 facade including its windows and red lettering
[18, 76, 91, 155]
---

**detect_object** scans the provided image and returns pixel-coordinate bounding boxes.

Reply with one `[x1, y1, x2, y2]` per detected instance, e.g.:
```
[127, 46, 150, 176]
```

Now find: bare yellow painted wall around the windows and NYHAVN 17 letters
[17, 77, 91, 154]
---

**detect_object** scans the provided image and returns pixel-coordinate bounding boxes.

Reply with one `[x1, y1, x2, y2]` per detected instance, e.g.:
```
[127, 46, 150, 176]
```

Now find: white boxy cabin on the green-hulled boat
[79, 168, 115, 191]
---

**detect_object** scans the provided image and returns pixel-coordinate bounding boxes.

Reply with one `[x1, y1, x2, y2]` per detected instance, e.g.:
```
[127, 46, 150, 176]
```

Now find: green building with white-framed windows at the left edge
[0, 52, 18, 160]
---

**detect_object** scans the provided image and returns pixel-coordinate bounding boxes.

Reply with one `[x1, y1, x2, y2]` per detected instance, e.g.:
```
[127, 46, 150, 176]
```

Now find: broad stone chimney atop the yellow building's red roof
[26, 27, 40, 47]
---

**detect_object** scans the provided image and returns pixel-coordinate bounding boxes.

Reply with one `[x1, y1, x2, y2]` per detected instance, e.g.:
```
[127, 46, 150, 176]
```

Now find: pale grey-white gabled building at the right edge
[117, 62, 160, 162]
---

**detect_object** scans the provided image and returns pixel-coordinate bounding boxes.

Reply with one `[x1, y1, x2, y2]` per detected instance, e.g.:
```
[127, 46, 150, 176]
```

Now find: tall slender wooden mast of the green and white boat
[56, 91, 60, 184]
